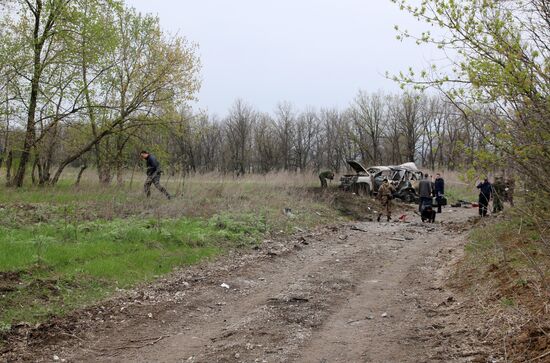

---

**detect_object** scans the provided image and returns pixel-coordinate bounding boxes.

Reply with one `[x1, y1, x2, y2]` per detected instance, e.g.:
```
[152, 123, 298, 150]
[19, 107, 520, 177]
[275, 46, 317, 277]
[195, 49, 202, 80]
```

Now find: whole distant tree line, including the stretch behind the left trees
[4, 91, 483, 183]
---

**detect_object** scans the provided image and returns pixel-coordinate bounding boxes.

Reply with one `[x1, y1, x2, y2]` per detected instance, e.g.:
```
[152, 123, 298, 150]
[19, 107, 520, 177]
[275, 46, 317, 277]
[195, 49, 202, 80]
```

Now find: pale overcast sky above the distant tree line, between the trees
[126, 0, 434, 116]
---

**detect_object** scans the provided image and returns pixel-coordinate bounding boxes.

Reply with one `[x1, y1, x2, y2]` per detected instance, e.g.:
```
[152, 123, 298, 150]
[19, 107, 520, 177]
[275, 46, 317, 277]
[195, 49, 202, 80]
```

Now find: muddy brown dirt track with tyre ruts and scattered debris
[3, 209, 490, 362]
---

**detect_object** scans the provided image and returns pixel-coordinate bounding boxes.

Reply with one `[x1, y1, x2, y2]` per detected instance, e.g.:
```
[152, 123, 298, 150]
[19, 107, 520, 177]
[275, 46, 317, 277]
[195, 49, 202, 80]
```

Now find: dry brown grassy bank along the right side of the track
[454, 210, 550, 361]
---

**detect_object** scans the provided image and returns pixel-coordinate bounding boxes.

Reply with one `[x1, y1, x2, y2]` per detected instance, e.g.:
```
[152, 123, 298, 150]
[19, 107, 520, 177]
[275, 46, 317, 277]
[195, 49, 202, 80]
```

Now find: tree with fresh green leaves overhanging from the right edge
[392, 0, 550, 195]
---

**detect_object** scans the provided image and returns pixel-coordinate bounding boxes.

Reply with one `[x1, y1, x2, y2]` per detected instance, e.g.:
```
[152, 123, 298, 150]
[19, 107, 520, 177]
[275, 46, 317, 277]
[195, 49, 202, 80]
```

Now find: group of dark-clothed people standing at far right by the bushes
[477, 176, 515, 217]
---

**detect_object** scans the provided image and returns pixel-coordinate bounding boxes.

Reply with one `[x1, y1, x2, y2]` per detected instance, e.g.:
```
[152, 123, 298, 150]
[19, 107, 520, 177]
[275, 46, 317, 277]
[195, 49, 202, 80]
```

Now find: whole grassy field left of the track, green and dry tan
[0, 176, 354, 331]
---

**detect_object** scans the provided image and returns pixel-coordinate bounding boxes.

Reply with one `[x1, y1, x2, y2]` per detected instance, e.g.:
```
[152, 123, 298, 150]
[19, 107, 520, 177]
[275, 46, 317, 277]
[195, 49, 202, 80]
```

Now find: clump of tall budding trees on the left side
[0, 0, 200, 187]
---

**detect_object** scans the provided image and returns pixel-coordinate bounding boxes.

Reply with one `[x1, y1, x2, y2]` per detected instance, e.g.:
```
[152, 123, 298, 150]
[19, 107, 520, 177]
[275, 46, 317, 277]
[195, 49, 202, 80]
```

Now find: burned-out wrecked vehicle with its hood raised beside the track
[340, 160, 422, 203]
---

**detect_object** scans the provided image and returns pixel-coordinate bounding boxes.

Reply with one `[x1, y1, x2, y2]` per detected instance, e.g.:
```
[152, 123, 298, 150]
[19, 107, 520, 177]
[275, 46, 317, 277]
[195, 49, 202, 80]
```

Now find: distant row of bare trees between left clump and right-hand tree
[168, 91, 479, 174]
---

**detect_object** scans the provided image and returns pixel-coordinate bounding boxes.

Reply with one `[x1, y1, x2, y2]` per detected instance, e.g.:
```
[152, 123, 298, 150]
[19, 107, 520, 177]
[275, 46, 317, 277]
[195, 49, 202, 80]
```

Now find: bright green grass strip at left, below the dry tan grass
[0, 216, 264, 328]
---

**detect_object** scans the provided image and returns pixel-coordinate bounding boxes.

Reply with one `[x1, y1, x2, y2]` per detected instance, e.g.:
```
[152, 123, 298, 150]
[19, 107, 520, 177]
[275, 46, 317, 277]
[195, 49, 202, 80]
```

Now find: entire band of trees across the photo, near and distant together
[0, 0, 550, 188]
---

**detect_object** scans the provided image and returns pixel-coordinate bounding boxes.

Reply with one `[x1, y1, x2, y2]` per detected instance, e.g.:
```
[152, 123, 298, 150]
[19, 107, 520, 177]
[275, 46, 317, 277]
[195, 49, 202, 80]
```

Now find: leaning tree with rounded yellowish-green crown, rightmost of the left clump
[51, 3, 200, 184]
